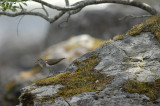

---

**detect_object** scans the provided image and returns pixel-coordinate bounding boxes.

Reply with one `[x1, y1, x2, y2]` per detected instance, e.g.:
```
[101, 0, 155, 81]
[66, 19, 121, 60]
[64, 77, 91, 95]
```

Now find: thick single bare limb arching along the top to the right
[33, 0, 157, 15]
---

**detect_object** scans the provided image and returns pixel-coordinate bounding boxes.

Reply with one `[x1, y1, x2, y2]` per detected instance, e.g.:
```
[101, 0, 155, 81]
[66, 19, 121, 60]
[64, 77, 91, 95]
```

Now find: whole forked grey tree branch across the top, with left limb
[0, 0, 157, 23]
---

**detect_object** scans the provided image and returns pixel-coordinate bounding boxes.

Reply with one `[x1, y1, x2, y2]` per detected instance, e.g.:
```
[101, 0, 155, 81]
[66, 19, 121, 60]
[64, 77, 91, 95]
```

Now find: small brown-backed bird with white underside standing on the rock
[36, 58, 66, 74]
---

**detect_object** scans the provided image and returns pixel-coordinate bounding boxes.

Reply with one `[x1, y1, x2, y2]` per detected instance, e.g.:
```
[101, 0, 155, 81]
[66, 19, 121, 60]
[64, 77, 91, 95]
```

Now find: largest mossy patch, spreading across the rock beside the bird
[35, 54, 113, 98]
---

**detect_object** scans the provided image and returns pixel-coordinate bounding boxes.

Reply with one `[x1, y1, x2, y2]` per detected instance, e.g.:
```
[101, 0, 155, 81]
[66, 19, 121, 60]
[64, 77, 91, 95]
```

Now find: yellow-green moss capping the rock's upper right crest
[126, 14, 160, 42]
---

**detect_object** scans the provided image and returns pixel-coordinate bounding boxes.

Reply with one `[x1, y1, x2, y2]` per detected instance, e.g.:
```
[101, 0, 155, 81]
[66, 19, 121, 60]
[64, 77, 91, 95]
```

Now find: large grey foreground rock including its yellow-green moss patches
[20, 16, 160, 106]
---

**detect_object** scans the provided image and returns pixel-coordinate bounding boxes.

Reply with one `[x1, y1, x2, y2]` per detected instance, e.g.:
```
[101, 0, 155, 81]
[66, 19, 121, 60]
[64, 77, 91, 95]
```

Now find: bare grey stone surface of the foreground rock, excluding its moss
[18, 32, 160, 106]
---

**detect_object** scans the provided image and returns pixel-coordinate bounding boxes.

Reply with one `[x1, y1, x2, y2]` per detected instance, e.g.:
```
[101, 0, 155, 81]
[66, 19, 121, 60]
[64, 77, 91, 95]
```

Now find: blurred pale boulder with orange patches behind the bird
[4, 34, 102, 105]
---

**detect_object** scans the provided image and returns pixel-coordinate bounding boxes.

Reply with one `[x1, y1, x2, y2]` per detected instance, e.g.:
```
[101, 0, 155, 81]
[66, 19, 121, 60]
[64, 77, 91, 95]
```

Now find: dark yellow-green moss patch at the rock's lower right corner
[123, 79, 160, 103]
